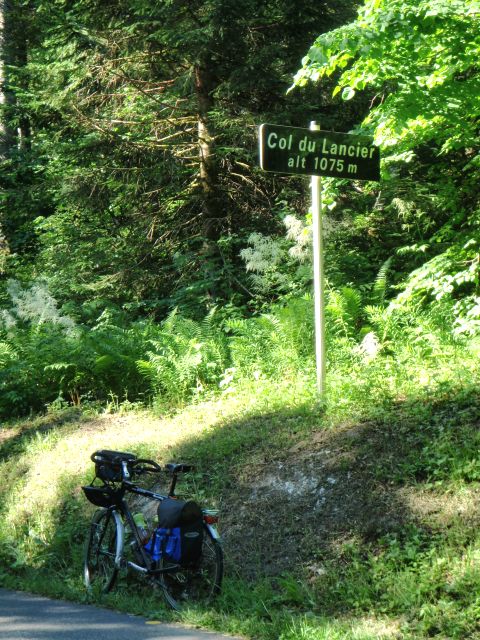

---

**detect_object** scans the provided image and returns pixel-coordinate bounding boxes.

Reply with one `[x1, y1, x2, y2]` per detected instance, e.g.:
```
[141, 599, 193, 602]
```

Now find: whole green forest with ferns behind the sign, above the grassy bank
[0, 0, 480, 417]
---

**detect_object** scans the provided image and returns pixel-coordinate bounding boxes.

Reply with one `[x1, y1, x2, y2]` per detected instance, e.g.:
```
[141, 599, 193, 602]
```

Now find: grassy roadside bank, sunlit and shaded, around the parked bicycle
[0, 332, 480, 640]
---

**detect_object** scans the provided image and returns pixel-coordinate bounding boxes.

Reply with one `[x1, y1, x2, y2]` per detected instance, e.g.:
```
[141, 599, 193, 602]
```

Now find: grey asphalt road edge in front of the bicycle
[0, 589, 240, 640]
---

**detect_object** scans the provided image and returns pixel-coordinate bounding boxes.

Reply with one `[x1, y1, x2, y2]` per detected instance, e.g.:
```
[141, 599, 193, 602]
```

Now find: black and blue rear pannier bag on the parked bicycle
[145, 498, 203, 567]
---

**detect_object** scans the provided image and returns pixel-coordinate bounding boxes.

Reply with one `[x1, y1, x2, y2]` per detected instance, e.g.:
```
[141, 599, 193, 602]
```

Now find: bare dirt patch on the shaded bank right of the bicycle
[221, 424, 480, 577]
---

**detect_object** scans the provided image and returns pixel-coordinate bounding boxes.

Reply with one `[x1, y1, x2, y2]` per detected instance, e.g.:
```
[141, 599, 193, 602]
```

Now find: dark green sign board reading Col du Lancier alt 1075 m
[259, 124, 380, 180]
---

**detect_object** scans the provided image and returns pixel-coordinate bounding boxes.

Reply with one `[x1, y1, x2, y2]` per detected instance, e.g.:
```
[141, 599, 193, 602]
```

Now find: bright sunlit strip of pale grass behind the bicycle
[2, 385, 320, 556]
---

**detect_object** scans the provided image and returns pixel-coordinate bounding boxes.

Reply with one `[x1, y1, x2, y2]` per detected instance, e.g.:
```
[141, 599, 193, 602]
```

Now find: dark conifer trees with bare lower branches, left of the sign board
[0, 0, 351, 322]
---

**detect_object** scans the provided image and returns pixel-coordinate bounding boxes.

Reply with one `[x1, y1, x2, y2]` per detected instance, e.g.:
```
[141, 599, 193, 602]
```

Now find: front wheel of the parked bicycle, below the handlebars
[83, 509, 123, 593]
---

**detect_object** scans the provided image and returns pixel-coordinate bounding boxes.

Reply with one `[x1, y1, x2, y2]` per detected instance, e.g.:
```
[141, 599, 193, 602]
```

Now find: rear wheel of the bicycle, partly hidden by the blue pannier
[158, 527, 223, 611]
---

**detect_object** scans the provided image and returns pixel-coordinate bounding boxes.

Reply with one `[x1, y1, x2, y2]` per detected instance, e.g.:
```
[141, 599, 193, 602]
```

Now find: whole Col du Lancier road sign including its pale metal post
[259, 122, 380, 398]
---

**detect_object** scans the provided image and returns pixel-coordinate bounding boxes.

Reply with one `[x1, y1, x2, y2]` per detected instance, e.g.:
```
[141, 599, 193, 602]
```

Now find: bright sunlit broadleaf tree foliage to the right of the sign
[295, 0, 480, 333]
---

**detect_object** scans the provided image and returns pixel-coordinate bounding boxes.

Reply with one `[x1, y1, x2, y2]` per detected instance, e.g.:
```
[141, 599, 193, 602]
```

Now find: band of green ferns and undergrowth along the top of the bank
[0, 272, 470, 416]
